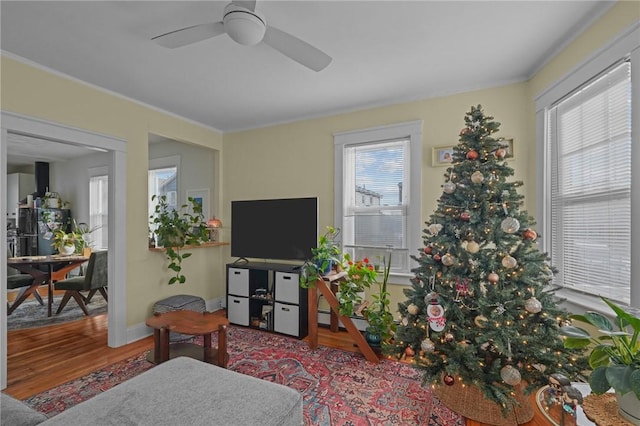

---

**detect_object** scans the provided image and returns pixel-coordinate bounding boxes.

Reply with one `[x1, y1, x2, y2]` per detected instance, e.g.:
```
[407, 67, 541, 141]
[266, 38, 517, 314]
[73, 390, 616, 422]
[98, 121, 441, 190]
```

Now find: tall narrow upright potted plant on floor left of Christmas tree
[362, 253, 396, 346]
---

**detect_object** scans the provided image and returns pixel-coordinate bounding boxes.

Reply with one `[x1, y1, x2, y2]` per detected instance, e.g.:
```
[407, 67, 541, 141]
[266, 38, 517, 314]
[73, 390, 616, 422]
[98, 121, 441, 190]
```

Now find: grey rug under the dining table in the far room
[7, 291, 107, 330]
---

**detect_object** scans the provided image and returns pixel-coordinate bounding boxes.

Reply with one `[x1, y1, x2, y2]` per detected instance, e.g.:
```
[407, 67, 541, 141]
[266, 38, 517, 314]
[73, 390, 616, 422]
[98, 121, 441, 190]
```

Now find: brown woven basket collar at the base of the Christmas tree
[434, 380, 533, 426]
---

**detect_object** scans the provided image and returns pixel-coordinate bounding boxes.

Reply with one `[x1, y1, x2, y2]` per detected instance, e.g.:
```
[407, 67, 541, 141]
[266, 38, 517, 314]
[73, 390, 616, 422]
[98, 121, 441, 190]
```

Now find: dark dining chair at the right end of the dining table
[54, 250, 108, 315]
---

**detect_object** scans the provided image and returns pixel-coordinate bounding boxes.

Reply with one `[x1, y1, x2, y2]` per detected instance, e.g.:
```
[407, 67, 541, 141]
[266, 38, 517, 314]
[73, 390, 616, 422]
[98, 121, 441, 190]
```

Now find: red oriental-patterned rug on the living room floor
[25, 326, 465, 426]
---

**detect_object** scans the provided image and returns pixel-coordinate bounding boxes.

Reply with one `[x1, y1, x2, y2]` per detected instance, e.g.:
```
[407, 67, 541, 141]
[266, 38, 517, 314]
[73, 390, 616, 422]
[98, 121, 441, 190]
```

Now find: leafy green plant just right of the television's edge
[300, 226, 342, 288]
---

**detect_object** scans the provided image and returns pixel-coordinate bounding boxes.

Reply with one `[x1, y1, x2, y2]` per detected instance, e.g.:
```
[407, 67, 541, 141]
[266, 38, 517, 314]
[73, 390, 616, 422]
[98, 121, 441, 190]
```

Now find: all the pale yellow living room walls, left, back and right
[0, 1, 640, 326]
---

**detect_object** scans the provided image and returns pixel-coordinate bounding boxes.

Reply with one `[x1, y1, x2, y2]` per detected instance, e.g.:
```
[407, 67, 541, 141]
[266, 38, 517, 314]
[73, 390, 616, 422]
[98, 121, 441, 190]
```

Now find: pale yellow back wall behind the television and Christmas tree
[223, 83, 534, 302]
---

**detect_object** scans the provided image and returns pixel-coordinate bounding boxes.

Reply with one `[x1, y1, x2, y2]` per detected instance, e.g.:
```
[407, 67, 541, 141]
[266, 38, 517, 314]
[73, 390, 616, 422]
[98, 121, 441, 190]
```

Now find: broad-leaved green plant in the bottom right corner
[560, 298, 640, 424]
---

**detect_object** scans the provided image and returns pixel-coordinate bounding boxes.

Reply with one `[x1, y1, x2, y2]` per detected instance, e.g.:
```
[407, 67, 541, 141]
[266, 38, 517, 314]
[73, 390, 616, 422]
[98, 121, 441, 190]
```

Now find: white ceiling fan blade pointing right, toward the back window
[262, 26, 331, 71]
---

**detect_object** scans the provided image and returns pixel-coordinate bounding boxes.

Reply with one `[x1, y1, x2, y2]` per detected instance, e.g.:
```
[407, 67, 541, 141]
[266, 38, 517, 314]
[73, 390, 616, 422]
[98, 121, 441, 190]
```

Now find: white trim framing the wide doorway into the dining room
[0, 112, 127, 389]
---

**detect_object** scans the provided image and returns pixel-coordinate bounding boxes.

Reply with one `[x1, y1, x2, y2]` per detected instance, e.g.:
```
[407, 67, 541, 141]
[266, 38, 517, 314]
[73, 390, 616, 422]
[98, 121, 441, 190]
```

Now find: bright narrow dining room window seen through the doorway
[87, 176, 109, 249]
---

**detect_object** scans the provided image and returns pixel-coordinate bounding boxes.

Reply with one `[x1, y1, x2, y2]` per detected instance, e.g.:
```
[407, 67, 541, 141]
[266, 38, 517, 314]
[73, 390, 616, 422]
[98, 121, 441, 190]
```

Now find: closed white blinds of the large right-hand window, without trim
[547, 61, 632, 304]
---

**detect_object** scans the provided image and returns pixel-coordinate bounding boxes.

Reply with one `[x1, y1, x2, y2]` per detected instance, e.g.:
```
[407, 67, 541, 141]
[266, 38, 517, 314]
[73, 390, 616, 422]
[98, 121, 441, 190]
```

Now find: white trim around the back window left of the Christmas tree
[333, 120, 422, 285]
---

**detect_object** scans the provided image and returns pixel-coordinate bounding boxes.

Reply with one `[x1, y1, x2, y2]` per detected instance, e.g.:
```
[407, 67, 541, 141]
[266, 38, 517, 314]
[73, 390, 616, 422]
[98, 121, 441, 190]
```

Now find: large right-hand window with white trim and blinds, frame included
[537, 25, 640, 308]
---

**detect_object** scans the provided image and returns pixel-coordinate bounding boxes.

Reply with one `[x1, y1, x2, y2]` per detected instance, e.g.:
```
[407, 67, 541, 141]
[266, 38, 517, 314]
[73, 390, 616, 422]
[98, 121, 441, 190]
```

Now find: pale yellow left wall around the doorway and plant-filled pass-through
[0, 57, 225, 326]
